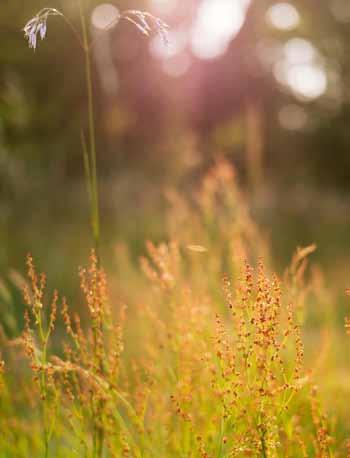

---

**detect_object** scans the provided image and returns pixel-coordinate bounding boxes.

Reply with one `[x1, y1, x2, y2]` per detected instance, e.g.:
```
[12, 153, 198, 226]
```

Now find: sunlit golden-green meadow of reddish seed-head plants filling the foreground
[1, 161, 350, 458]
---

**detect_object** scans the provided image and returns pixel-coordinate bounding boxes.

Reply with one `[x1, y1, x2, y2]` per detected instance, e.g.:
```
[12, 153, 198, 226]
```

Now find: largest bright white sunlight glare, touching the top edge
[191, 0, 250, 59]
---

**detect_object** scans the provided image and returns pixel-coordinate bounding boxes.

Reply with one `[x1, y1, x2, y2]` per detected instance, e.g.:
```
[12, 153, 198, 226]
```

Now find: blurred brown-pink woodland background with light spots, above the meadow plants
[0, 0, 350, 294]
